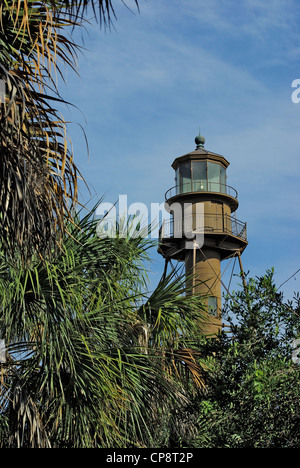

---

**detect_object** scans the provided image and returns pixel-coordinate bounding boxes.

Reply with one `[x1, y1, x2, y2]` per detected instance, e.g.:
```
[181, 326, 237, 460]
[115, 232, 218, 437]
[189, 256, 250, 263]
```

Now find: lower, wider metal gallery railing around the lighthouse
[159, 214, 247, 241]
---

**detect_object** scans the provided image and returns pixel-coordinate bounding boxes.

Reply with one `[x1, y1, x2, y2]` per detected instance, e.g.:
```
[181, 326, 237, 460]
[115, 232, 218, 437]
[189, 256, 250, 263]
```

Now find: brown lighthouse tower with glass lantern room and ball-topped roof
[159, 134, 247, 335]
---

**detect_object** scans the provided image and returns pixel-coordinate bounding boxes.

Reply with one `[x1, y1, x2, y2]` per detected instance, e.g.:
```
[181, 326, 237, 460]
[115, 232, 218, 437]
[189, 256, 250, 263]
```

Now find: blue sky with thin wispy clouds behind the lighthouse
[60, 0, 300, 299]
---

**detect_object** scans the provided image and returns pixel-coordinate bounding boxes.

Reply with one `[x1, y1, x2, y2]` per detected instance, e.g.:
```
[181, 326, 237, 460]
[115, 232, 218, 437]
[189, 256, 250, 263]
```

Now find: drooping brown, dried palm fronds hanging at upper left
[0, 0, 137, 258]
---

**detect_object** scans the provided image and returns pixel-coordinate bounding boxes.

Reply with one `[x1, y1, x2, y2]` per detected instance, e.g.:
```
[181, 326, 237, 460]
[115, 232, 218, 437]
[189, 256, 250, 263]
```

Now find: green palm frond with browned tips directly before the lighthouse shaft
[137, 269, 207, 388]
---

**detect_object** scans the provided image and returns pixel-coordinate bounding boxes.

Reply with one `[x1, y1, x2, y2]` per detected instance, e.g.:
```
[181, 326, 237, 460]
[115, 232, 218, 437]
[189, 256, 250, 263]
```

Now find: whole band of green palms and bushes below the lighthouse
[0, 258, 300, 448]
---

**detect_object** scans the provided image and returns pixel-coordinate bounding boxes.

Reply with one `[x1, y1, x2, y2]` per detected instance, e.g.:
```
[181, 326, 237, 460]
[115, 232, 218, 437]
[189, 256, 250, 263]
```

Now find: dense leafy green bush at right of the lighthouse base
[178, 271, 300, 448]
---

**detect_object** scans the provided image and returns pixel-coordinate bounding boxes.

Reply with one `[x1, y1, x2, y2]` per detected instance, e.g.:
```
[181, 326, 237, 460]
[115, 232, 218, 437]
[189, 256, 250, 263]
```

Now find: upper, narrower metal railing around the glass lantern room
[165, 181, 238, 200]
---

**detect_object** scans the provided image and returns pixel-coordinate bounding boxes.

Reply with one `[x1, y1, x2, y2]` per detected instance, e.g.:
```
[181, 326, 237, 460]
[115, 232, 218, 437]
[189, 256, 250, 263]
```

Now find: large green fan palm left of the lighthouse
[0, 205, 204, 447]
